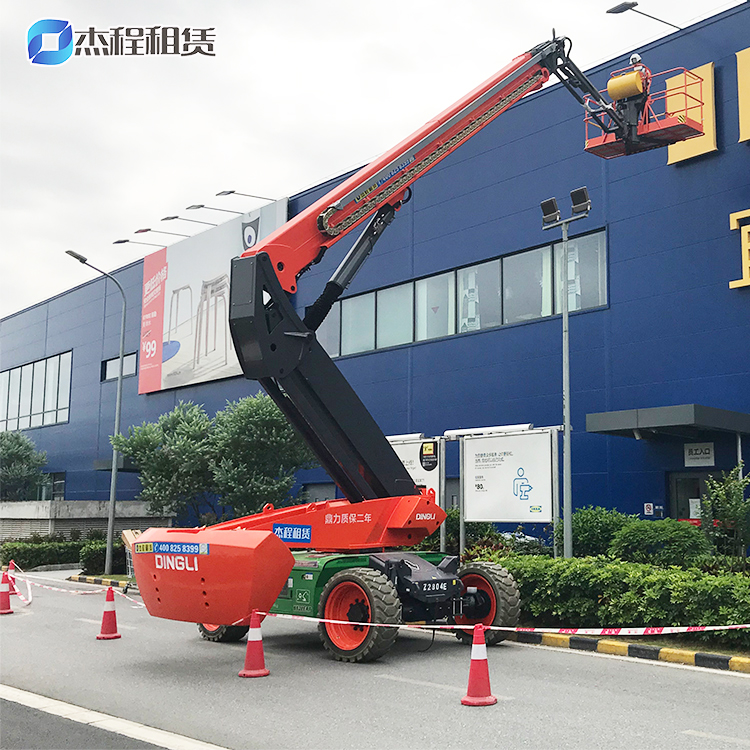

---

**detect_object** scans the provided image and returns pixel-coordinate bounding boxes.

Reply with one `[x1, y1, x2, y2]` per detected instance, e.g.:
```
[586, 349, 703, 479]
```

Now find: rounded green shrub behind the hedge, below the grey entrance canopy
[609, 518, 711, 566]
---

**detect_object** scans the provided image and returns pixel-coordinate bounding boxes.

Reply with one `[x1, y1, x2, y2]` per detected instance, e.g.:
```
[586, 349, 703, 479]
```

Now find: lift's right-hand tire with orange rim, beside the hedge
[455, 562, 521, 646]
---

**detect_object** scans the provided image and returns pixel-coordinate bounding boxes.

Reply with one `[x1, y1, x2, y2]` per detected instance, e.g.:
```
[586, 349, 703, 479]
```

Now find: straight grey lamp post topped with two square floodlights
[541, 187, 591, 557]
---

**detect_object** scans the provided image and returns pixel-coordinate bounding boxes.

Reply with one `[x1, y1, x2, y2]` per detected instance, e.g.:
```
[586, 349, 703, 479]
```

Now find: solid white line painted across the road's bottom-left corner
[0, 684, 232, 750]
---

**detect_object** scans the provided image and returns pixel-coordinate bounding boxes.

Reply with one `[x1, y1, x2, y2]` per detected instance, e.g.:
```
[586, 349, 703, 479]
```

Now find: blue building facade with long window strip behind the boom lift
[0, 4, 750, 536]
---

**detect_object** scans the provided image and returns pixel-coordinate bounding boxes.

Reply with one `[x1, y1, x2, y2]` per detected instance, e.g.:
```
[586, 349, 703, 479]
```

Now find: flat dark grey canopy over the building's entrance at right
[586, 404, 750, 441]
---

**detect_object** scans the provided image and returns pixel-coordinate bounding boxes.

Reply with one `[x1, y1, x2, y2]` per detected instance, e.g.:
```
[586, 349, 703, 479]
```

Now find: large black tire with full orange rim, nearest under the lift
[318, 568, 401, 662]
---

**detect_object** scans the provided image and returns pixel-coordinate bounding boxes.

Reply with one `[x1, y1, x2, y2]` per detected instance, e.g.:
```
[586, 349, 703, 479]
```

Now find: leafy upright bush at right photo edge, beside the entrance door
[701, 461, 750, 559]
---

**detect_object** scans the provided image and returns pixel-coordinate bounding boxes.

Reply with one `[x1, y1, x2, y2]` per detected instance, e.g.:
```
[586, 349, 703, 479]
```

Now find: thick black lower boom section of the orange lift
[229, 253, 418, 502]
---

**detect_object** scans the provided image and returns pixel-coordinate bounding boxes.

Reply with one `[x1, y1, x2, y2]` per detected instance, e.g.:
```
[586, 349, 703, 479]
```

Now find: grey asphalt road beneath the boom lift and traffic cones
[0, 574, 750, 750]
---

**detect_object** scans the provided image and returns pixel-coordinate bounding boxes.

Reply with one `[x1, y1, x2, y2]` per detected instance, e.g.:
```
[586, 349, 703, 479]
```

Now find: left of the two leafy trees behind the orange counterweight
[111, 401, 223, 517]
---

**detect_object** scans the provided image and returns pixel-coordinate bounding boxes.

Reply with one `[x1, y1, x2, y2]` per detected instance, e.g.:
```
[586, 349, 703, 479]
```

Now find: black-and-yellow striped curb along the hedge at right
[508, 633, 750, 674]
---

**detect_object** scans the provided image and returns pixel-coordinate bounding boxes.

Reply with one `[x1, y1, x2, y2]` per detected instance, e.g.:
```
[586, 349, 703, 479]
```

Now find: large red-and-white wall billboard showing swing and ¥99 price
[138, 203, 287, 393]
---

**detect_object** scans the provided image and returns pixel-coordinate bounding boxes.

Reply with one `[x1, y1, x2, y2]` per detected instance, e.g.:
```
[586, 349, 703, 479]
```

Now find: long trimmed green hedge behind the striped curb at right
[473, 550, 750, 646]
